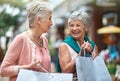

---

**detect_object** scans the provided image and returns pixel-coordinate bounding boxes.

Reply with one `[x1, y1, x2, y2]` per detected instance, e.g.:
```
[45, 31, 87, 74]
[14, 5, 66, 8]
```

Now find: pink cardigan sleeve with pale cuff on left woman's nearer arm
[0, 35, 23, 77]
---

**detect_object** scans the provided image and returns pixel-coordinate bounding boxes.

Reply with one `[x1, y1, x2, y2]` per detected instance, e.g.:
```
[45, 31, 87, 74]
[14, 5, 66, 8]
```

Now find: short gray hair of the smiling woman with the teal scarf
[68, 10, 89, 26]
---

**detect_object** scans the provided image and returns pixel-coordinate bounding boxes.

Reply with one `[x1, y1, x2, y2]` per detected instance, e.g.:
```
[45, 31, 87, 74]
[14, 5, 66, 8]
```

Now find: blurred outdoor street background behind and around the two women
[0, 0, 120, 81]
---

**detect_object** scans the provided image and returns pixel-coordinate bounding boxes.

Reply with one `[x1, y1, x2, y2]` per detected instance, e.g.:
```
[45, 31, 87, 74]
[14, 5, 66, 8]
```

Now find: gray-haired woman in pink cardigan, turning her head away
[0, 1, 52, 81]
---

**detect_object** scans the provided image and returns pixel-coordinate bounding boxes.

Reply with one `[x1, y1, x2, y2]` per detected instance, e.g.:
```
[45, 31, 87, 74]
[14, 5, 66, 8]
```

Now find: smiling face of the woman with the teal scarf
[69, 19, 85, 40]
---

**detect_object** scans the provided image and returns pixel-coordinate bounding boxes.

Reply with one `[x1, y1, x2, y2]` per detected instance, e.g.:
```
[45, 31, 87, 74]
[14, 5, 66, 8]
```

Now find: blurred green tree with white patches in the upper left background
[0, 0, 27, 53]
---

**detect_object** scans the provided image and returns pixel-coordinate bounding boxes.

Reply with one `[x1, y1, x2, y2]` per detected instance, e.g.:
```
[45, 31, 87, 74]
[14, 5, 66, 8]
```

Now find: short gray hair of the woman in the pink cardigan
[27, 0, 51, 23]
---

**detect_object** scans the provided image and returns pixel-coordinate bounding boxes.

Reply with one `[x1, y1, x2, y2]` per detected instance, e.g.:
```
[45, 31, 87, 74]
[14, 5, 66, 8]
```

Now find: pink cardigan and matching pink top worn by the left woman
[0, 32, 51, 81]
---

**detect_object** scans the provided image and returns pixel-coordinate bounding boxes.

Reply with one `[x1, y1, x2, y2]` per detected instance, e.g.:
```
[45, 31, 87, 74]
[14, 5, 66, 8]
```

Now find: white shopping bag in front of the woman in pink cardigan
[17, 69, 73, 81]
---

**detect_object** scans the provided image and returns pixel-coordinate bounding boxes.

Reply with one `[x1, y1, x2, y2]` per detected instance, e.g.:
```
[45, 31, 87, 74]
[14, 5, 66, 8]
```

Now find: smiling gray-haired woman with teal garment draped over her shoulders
[59, 10, 98, 81]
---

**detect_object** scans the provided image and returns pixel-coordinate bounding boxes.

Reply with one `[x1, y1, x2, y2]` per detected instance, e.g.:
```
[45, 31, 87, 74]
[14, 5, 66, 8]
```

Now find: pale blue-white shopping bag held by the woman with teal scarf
[76, 56, 112, 81]
